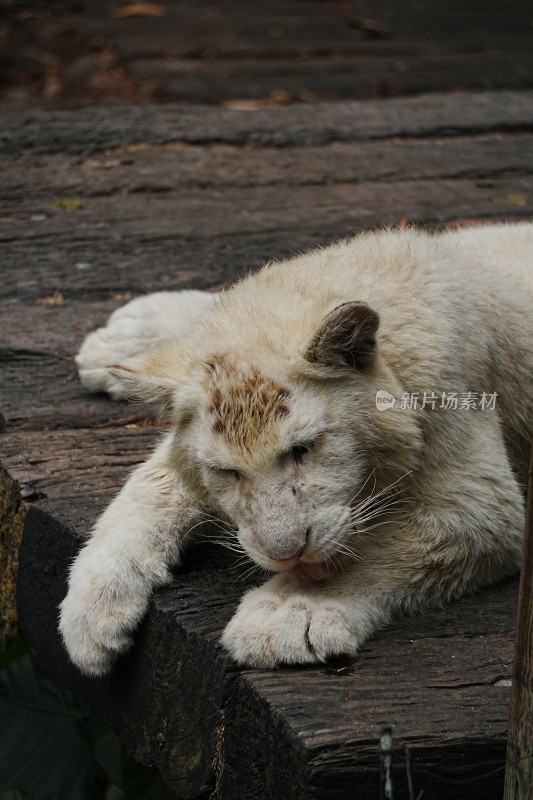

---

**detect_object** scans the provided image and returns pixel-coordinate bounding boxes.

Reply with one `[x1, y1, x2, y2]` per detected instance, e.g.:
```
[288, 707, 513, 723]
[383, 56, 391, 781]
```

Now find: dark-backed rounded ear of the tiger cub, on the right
[303, 302, 379, 369]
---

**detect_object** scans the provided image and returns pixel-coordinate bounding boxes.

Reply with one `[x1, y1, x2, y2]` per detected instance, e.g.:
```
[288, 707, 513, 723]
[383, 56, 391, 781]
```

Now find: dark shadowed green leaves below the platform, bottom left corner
[0, 655, 179, 800]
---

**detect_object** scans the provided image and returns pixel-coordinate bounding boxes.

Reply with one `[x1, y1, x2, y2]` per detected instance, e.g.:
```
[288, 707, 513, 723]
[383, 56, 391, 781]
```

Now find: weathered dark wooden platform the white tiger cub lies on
[0, 92, 533, 800]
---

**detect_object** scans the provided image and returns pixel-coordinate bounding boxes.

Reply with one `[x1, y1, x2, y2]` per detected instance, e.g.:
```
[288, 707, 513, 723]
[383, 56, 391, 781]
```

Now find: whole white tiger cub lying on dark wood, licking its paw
[60, 224, 533, 675]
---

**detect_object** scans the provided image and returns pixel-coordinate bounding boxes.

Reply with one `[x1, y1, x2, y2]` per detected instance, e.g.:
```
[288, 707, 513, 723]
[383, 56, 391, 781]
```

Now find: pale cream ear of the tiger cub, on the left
[107, 342, 192, 419]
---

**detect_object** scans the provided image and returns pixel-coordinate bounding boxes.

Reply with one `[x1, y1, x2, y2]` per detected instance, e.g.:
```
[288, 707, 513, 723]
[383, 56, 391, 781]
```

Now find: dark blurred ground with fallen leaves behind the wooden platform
[0, 0, 533, 108]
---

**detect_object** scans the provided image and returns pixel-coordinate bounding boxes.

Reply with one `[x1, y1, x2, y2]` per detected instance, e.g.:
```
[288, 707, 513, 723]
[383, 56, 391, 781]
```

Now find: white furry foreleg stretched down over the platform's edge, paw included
[60, 439, 200, 675]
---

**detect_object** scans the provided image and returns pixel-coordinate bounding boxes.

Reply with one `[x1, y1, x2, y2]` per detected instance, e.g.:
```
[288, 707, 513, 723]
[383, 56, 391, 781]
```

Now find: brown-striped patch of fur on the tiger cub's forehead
[206, 358, 290, 450]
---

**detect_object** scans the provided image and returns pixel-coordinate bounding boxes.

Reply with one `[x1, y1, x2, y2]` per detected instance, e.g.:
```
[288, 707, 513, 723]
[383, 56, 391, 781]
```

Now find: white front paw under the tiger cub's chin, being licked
[222, 578, 368, 668]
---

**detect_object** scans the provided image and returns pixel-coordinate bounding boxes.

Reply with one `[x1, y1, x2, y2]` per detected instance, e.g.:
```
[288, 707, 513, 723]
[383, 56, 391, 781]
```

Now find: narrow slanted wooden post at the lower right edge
[504, 446, 533, 800]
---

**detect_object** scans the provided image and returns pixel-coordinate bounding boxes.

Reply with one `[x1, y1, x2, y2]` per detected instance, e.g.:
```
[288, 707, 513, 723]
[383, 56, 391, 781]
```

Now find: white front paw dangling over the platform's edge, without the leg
[59, 575, 148, 676]
